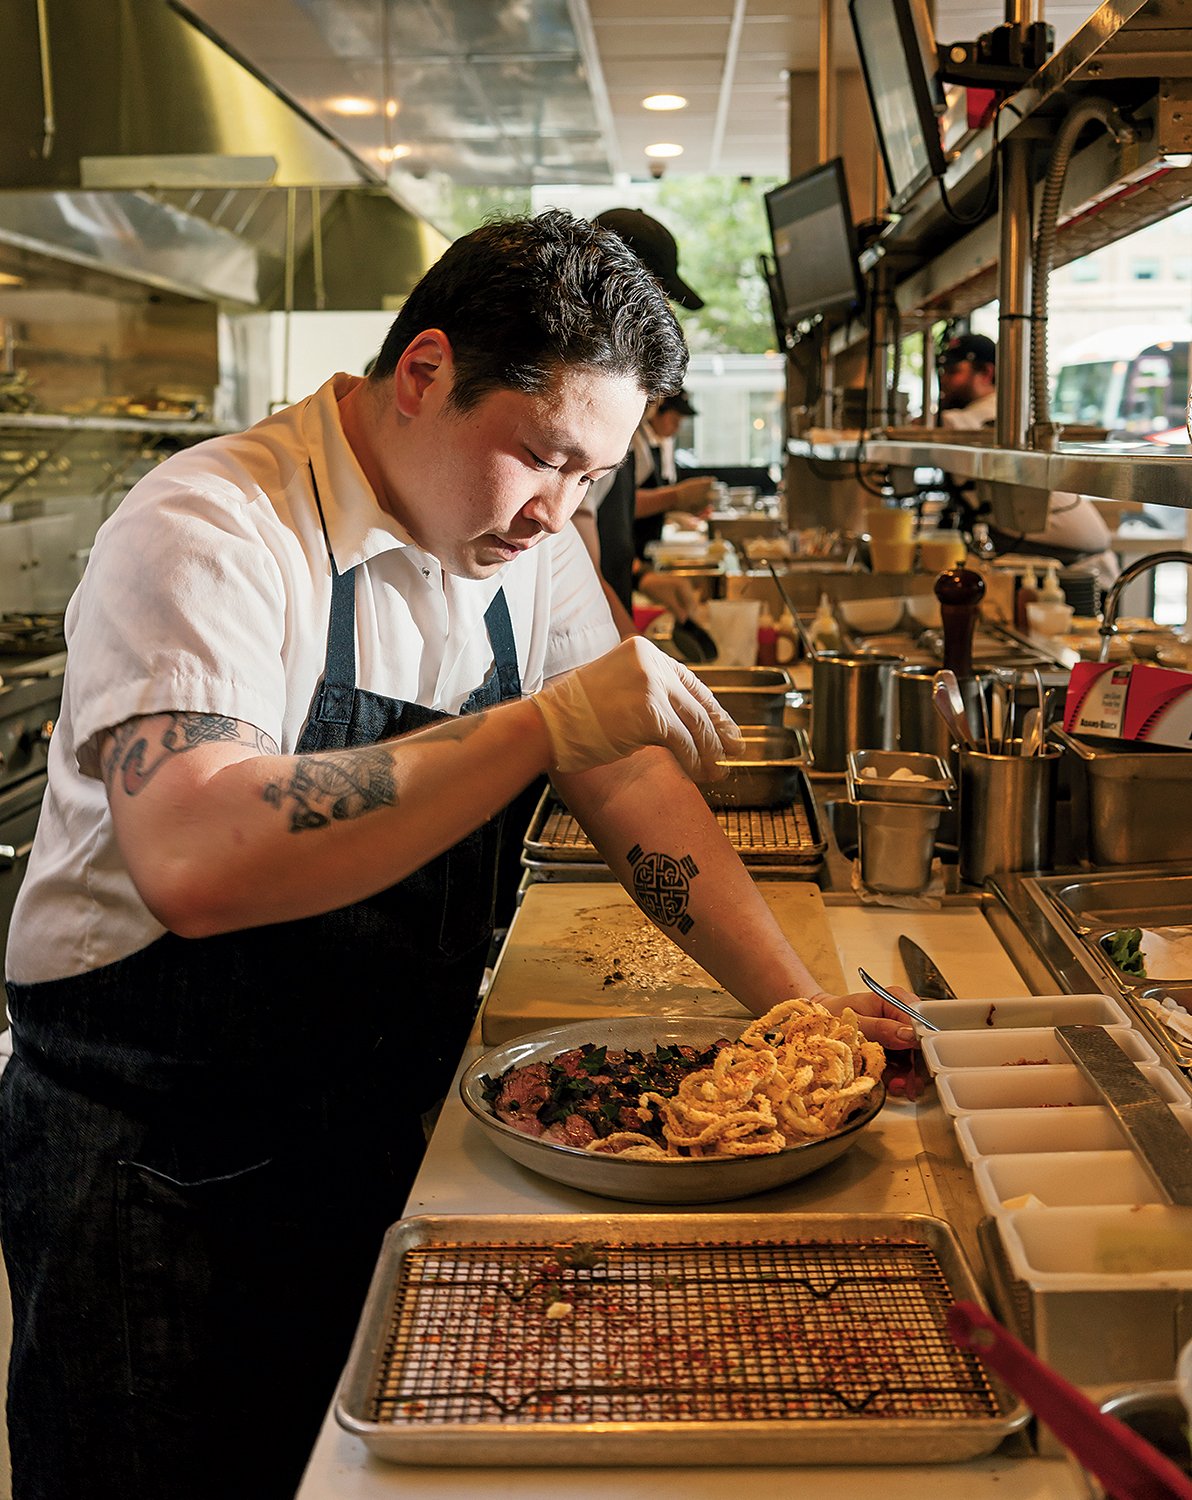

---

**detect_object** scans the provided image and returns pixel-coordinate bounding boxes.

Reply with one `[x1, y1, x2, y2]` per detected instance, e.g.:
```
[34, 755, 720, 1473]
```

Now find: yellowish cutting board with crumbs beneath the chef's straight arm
[481, 881, 844, 1046]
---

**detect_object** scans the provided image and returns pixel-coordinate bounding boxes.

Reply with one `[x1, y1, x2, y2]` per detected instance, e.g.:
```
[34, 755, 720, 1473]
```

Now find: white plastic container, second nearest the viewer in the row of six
[973, 1148, 1164, 1215]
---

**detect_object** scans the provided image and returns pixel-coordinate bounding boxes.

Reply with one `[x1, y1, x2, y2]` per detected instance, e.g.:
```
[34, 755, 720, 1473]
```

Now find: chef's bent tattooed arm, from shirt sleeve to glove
[100, 701, 549, 938]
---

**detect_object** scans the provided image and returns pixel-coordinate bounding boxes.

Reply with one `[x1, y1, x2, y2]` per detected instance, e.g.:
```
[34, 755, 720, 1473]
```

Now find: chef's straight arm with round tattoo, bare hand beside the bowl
[555, 750, 913, 1047]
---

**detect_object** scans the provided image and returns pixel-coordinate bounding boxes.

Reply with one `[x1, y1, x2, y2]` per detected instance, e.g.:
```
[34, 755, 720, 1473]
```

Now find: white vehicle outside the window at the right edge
[1051, 323, 1192, 444]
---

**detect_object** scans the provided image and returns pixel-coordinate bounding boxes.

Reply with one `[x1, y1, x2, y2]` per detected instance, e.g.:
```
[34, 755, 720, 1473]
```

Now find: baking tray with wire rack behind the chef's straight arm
[522, 768, 828, 881]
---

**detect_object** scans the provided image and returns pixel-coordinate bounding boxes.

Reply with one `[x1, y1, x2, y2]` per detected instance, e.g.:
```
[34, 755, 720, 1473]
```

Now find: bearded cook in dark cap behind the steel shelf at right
[939, 333, 1122, 588]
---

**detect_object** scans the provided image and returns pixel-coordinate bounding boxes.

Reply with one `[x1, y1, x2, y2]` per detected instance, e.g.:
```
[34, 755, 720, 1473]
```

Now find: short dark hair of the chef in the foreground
[369, 209, 687, 411]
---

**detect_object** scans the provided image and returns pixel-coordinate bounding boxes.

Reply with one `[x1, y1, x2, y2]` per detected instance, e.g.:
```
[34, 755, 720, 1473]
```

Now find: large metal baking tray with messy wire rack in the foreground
[336, 1214, 1029, 1467]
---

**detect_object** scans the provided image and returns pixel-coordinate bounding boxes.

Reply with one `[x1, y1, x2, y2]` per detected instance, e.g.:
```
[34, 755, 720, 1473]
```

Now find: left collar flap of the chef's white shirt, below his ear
[301, 374, 414, 573]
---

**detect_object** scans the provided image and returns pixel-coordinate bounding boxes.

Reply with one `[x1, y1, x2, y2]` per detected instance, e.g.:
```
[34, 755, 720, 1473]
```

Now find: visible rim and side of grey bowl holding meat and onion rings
[459, 1016, 886, 1205]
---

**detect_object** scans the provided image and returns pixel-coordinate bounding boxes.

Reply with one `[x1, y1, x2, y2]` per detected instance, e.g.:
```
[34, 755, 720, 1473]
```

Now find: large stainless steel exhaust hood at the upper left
[0, 0, 447, 311]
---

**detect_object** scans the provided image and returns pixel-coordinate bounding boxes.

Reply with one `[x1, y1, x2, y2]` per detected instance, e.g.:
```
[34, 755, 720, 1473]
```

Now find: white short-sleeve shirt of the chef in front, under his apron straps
[6, 375, 618, 984]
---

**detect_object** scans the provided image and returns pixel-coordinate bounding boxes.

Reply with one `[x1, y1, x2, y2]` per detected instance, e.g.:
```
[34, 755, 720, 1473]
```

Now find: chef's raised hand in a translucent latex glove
[532, 636, 741, 782]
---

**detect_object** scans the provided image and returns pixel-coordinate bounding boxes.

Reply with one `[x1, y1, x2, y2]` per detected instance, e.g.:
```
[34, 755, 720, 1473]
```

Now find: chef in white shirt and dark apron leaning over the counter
[0, 212, 910, 1500]
